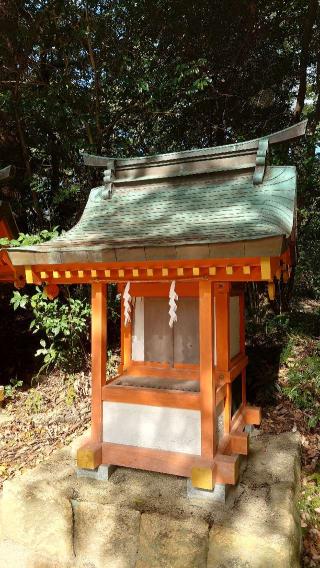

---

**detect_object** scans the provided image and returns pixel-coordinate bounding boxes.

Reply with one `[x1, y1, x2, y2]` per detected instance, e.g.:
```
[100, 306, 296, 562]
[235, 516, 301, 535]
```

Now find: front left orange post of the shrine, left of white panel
[91, 282, 107, 442]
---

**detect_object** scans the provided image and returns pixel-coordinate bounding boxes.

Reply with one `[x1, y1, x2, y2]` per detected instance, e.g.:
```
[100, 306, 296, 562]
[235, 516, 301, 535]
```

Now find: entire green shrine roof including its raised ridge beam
[8, 121, 307, 266]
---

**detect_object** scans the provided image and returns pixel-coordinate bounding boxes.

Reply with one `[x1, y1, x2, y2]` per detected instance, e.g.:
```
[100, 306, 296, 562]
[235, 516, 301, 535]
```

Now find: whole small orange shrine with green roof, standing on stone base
[4, 122, 306, 489]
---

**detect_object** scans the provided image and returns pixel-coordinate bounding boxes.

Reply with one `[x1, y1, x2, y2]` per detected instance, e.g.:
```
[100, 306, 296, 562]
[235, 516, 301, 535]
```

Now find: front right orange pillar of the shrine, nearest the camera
[199, 280, 217, 460]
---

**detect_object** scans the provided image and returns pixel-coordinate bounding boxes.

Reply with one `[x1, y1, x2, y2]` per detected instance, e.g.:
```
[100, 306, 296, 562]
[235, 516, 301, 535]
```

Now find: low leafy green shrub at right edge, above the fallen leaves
[283, 345, 320, 428]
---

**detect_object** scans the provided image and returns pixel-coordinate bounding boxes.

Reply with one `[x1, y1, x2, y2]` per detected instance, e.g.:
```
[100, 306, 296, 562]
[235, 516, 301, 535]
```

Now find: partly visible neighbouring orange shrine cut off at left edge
[0, 166, 18, 282]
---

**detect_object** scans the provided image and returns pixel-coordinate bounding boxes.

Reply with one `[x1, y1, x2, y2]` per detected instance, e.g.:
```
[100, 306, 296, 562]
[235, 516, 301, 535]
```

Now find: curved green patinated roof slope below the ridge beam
[10, 162, 296, 262]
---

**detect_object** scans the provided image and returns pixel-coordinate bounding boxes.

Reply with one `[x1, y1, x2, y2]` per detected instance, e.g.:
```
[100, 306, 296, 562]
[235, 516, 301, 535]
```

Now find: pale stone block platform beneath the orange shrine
[0, 433, 301, 568]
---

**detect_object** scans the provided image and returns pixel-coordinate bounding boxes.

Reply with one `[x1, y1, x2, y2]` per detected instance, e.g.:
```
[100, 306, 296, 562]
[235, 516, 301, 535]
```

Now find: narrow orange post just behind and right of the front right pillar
[214, 282, 232, 434]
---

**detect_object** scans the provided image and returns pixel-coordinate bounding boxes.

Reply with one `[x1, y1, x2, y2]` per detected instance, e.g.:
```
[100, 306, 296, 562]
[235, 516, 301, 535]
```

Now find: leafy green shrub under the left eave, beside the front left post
[11, 287, 90, 370]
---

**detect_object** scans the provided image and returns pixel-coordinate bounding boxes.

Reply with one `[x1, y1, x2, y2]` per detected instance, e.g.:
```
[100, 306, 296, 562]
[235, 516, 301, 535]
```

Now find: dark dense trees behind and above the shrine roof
[0, 0, 320, 289]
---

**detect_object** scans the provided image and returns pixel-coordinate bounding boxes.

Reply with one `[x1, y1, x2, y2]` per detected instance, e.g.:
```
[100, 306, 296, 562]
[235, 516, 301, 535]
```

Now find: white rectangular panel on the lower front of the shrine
[103, 402, 201, 455]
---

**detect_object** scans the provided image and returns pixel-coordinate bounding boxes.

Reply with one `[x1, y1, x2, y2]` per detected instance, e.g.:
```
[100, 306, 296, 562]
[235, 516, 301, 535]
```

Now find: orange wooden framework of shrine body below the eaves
[79, 279, 261, 483]
